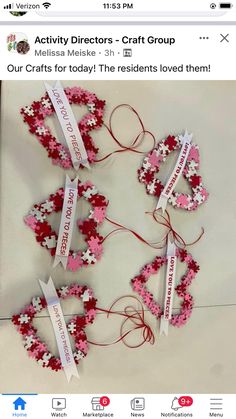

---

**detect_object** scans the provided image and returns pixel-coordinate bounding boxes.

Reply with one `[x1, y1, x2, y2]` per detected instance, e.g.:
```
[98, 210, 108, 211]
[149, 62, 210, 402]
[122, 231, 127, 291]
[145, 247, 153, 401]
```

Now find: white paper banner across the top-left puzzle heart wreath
[45, 81, 90, 170]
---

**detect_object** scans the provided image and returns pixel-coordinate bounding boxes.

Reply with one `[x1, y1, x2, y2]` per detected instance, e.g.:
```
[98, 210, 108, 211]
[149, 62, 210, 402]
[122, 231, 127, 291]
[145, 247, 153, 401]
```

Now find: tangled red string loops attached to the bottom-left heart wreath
[88, 295, 155, 349]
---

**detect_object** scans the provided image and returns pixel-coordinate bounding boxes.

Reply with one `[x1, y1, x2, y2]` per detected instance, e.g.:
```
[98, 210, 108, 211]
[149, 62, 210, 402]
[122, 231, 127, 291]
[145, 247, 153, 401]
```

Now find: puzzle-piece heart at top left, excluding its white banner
[20, 87, 105, 169]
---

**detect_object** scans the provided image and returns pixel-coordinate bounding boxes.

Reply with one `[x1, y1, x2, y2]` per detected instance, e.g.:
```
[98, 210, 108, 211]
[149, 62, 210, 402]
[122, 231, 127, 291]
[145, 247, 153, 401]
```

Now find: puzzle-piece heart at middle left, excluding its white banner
[24, 181, 108, 272]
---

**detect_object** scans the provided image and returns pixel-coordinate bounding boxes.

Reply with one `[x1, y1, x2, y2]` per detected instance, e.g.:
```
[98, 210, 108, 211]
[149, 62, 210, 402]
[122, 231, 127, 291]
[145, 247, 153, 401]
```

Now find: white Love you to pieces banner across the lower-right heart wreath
[160, 240, 177, 336]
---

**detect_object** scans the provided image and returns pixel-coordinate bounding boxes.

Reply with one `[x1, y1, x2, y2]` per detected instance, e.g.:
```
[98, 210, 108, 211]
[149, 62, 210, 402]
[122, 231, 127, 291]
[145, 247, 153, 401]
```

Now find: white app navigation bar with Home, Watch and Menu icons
[0, 393, 232, 419]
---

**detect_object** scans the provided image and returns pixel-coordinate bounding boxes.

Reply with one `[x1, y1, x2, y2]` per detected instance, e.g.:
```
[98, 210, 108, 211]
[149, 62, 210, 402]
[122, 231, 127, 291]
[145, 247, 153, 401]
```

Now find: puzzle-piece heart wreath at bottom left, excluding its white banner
[12, 284, 97, 371]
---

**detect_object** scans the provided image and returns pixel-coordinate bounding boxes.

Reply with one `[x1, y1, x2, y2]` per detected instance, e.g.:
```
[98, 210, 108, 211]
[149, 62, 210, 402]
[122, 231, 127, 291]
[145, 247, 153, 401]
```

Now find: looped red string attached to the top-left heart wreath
[95, 103, 156, 163]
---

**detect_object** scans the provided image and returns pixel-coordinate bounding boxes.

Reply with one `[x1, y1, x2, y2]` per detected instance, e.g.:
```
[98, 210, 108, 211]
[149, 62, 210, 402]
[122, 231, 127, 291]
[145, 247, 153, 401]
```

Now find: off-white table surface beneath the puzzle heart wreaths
[0, 81, 236, 393]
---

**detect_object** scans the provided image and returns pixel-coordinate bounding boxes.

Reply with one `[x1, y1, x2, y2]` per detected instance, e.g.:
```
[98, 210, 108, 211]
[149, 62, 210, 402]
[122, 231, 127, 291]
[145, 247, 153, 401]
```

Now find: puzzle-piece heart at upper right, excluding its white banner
[138, 135, 208, 211]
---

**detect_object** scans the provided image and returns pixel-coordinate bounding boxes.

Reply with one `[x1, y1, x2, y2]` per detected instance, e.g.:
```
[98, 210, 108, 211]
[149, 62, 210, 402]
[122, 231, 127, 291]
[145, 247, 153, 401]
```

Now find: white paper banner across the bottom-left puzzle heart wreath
[39, 278, 79, 382]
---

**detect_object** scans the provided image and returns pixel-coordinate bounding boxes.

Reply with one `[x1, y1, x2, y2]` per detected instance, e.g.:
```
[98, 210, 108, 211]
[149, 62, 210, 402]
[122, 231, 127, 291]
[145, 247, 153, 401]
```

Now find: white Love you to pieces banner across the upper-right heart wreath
[156, 130, 193, 212]
